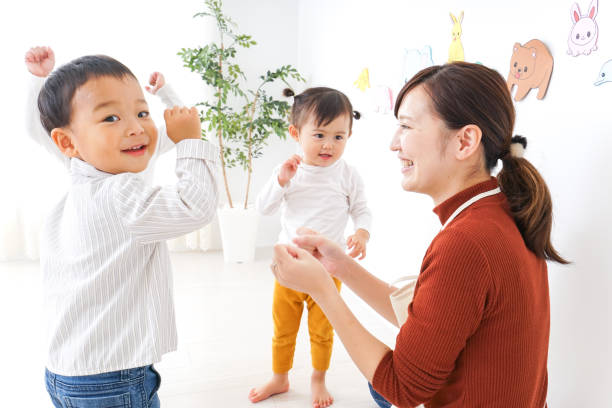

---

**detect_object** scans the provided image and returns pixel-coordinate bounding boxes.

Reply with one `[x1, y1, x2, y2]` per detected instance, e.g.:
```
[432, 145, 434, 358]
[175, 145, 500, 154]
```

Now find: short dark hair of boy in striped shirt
[38, 55, 136, 134]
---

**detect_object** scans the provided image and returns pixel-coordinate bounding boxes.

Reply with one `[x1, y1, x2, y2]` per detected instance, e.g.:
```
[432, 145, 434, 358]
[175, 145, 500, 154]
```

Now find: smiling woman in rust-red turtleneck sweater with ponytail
[272, 63, 567, 408]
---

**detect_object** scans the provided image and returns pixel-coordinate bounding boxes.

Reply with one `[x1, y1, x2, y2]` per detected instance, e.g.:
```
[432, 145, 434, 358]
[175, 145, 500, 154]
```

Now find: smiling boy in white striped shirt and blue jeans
[38, 56, 218, 408]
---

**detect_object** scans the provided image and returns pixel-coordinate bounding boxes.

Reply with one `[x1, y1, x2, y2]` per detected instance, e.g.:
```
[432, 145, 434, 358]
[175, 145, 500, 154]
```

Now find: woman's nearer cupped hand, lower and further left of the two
[271, 245, 336, 299]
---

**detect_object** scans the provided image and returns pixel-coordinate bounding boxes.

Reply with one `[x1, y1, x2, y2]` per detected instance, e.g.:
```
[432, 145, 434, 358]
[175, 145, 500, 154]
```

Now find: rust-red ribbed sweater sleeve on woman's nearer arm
[372, 229, 491, 407]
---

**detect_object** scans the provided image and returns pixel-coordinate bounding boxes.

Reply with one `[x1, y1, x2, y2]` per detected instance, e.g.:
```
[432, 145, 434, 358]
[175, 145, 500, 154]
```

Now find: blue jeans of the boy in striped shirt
[45, 365, 161, 408]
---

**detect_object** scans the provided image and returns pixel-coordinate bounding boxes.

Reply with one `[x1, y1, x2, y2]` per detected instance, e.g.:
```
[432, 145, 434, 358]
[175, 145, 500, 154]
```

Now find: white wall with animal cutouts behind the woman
[299, 0, 612, 408]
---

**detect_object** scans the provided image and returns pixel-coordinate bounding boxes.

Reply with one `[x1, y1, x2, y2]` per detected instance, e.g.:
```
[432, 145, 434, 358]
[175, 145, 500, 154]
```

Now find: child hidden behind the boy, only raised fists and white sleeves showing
[25, 47, 183, 185]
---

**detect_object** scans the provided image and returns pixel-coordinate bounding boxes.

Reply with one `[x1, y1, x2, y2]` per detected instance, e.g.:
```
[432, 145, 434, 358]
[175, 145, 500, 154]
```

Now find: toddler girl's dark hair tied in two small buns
[283, 87, 361, 130]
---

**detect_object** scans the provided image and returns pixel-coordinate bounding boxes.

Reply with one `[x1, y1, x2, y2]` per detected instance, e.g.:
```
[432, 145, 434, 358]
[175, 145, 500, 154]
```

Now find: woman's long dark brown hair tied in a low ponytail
[395, 62, 568, 264]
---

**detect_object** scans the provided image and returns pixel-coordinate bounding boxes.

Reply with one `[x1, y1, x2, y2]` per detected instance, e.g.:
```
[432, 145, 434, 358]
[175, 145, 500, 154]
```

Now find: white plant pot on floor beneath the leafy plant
[217, 207, 259, 263]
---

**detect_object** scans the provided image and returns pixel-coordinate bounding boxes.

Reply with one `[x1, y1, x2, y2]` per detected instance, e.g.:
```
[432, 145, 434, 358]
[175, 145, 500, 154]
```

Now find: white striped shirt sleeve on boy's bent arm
[112, 140, 219, 244]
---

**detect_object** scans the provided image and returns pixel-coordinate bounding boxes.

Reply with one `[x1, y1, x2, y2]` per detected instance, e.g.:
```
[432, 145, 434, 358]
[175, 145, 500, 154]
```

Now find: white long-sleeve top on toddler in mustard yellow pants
[257, 159, 372, 246]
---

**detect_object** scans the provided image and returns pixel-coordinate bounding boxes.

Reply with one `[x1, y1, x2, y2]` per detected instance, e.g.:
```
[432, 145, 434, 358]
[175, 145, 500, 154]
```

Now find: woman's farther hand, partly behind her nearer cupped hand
[293, 227, 353, 280]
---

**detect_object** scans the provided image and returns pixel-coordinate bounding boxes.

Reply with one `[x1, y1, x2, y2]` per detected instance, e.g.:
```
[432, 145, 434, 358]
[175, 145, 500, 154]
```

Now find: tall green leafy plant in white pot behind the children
[178, 0, 304, 262]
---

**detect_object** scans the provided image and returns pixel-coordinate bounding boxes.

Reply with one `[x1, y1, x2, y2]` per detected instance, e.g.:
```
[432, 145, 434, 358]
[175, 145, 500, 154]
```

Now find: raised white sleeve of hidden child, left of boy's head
[25, 75, 70, 167]
